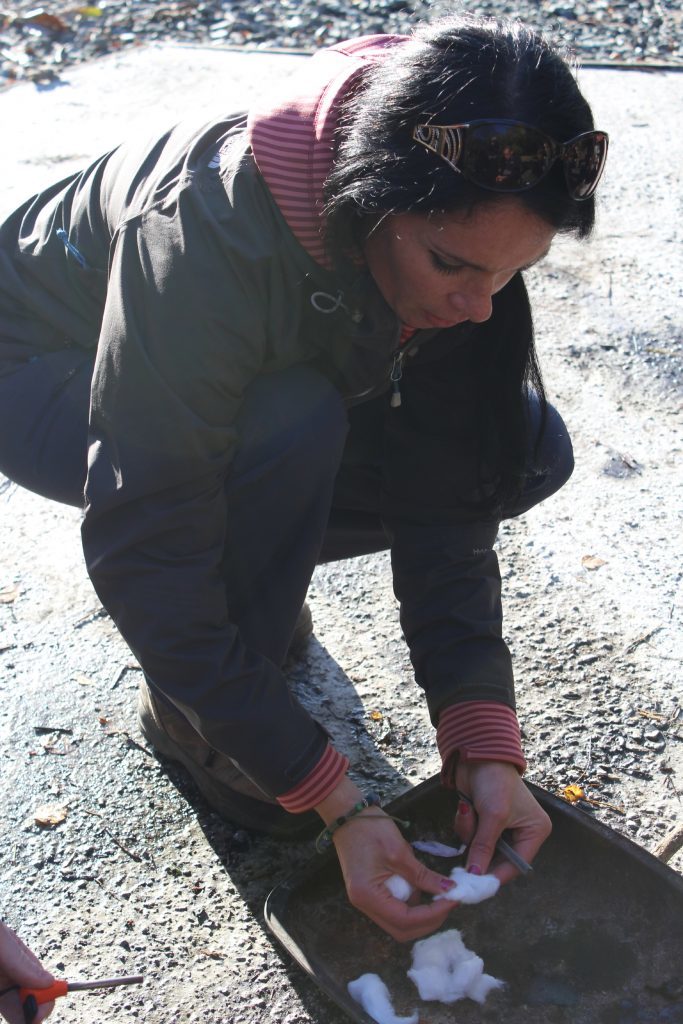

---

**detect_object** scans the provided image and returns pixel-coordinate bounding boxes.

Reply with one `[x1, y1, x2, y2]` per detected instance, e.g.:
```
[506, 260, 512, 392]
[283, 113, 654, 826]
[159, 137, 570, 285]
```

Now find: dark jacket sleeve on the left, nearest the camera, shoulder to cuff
[82, 201, 328, 796]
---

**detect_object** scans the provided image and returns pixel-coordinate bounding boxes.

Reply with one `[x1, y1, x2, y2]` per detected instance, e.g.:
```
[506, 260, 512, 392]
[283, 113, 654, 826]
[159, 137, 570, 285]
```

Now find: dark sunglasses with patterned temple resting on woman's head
[413, 118, 609, 200]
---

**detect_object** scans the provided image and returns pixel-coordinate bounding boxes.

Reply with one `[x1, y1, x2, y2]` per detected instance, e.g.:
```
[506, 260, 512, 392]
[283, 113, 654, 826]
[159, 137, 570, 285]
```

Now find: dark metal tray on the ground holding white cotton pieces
[265, 777, 683, 1024]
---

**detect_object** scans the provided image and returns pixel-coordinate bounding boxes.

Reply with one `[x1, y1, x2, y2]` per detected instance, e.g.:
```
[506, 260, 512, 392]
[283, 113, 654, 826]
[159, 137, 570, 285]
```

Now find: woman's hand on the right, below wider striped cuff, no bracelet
[456, 761, 551, 883]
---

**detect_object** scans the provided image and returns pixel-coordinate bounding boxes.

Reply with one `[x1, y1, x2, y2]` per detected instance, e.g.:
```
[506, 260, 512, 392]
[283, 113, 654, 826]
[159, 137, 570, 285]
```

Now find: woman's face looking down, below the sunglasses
[364, 199, 555, 328]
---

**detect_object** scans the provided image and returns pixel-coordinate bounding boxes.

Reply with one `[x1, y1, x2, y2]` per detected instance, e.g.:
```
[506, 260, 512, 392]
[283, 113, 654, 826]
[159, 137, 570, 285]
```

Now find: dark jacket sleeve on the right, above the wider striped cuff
[384, 279, 530, 725]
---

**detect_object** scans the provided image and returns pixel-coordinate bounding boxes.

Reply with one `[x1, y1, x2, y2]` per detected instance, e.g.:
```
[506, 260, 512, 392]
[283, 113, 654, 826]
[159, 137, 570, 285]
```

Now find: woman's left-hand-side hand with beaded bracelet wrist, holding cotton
[316, 778, 458, 942]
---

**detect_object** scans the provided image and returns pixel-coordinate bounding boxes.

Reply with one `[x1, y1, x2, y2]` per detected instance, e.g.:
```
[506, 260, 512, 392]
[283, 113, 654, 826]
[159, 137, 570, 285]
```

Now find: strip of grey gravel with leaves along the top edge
[0, 0, 683, 85]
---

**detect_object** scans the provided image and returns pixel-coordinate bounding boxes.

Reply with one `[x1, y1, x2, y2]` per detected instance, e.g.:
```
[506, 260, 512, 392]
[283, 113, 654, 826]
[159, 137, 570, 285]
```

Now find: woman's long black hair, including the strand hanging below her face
[324, 16, 595, 510]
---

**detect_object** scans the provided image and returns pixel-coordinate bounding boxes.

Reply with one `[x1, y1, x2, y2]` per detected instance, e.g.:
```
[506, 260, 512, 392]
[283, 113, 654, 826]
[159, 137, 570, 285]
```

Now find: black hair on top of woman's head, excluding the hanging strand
[324, 16, 595, 246]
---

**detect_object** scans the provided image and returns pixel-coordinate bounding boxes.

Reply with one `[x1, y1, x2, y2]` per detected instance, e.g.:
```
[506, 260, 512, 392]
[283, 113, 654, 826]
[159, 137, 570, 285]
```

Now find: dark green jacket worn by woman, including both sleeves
[0, 117, 530, 795]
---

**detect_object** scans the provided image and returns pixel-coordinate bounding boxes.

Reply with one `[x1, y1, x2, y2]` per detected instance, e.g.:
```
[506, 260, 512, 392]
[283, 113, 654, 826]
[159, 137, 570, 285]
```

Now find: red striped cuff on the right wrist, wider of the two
[436, 700, 526, 786]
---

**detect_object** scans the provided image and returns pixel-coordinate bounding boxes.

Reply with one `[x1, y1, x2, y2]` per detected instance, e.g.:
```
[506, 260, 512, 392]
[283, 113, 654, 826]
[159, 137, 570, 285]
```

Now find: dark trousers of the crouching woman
[0, 350, 573, 664]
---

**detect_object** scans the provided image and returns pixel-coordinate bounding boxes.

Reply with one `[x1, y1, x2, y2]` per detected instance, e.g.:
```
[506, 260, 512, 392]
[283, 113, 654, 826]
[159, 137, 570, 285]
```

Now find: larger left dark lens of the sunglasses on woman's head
[458, 121, 555, 191]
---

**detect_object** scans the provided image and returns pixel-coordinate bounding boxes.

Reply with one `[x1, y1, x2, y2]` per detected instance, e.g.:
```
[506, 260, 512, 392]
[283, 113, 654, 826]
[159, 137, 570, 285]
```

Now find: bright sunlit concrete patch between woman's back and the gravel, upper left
[0, 45, 306, 210]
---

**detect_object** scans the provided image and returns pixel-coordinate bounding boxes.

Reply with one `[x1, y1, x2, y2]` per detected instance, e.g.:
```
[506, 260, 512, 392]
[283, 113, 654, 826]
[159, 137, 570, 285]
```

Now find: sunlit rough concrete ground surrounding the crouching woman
[0, 39, 683, 1024]
